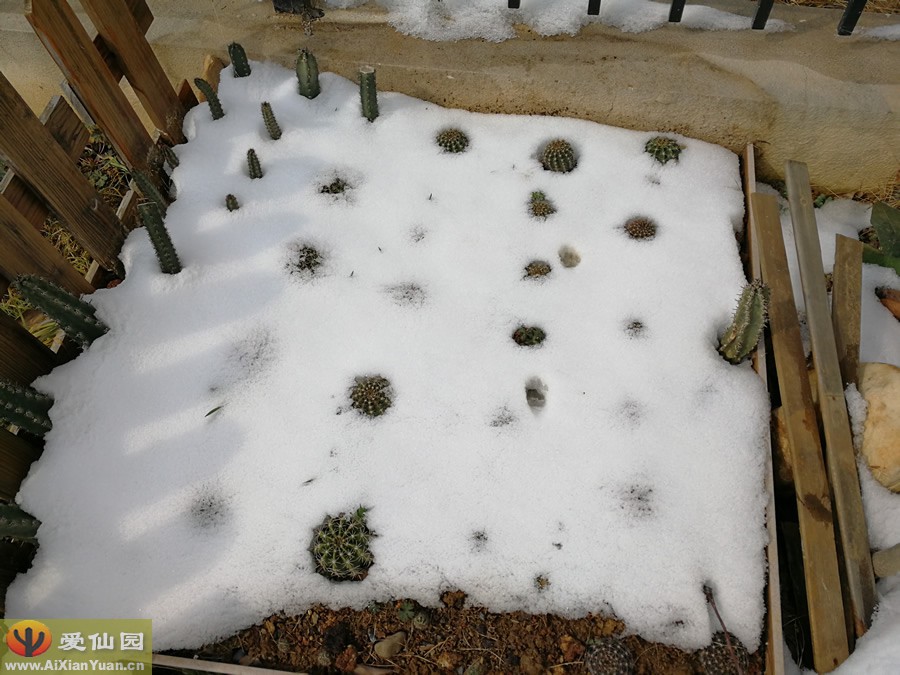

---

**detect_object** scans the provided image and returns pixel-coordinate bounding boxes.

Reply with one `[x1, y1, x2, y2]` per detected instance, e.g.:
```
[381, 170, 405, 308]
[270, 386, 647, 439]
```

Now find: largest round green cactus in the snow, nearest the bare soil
[311, 507, 375, 581]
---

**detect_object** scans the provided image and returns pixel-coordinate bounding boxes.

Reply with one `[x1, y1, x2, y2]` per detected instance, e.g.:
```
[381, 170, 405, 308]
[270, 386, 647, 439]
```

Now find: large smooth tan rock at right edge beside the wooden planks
[859, 363, 900, 492]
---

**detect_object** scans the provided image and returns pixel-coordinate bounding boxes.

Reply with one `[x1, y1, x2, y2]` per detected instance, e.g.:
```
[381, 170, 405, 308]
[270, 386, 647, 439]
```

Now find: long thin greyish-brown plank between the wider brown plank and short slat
[785, 161, 875, 637]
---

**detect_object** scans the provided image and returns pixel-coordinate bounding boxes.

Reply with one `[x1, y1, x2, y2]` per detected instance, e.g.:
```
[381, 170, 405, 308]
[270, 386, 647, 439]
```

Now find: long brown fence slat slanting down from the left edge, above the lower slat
[0, 73, 123, 269]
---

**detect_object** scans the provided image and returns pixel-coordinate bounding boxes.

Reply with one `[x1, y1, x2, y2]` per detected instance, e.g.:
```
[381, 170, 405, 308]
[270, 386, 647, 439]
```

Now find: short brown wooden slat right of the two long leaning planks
[831, 234, 862, 385]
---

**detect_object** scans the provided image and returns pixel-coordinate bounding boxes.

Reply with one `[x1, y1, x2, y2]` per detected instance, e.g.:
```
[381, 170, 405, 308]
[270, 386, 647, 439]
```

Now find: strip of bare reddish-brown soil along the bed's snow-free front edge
[165, 591, 764, 675]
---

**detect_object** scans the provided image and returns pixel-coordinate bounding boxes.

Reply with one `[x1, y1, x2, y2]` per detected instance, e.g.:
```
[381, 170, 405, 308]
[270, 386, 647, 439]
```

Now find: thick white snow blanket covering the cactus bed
[7, 60, 769, 649]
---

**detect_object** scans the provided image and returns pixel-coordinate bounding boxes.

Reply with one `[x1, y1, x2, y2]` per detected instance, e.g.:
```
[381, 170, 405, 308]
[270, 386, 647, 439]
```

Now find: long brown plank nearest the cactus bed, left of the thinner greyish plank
[750, 193, 848, 672]
